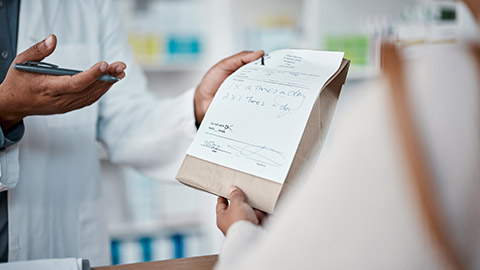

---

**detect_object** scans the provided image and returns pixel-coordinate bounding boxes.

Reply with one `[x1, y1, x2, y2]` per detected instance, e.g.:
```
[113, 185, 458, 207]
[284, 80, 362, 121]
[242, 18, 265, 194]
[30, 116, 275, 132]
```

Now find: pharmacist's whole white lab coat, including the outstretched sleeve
[0, 0, 195, 266]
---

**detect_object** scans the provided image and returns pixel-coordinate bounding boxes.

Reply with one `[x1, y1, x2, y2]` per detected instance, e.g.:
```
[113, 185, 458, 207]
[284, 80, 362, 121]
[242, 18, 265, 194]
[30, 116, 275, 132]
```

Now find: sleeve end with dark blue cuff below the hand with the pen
[0, 121, 25, 192]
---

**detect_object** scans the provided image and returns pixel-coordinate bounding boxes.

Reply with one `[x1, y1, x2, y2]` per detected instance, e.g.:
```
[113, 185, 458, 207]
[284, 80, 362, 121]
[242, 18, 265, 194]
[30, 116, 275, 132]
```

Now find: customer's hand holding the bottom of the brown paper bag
[217, 186, 266, 235]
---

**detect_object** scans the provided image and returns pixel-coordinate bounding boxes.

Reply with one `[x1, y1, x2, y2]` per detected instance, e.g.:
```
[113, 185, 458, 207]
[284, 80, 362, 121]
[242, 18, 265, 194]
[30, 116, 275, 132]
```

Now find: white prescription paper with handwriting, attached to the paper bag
[187, 50, 343, 183]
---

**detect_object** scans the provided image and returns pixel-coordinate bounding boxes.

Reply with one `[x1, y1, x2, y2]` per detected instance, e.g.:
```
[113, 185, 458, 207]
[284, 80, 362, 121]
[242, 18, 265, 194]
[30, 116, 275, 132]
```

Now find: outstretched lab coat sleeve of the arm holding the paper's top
[97, 1, 196, 179]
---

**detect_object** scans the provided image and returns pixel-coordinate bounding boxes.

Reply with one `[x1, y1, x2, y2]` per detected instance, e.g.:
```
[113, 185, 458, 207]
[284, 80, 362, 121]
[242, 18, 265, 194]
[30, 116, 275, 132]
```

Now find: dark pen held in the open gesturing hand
[13, 61, 119, 82]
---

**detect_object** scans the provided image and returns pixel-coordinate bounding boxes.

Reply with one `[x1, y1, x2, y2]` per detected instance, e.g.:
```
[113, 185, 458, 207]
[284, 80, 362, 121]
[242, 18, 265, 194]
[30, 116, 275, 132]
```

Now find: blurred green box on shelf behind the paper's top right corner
[326, 35, 370, 66]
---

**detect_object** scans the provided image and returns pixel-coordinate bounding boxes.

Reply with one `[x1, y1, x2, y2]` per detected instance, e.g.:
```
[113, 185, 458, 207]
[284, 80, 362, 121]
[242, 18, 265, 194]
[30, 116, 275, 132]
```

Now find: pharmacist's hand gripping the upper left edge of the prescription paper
[194, 51, 265, 124]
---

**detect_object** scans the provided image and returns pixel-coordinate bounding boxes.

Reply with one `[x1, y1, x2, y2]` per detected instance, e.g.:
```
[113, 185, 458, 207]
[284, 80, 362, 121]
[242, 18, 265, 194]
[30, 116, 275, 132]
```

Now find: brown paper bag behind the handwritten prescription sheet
[176, 59, 350, 213]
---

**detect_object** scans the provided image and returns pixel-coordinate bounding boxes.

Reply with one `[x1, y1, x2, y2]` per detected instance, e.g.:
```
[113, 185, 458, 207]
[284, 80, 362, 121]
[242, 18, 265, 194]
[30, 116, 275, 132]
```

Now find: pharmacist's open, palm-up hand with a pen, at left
[0, 35, 126, 130]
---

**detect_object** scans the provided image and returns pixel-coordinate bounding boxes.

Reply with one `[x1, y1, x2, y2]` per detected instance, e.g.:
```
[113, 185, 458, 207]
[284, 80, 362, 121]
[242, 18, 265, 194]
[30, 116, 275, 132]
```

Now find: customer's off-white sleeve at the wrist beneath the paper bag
[215, 220, 264, 269]
